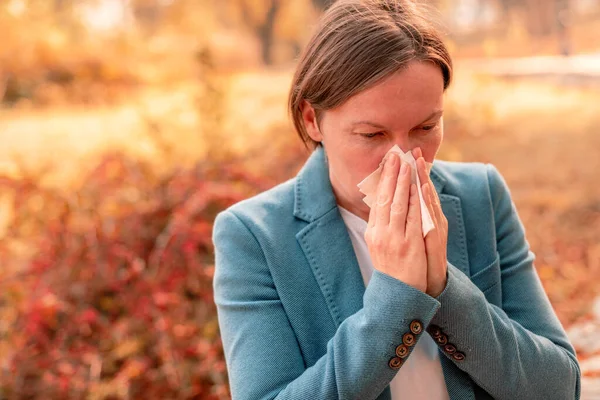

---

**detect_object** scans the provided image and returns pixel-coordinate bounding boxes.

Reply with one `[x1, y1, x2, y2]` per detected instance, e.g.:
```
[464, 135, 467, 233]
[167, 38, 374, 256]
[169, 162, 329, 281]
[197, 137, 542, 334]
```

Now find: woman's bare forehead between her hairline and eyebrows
[330, 61, 444, 128]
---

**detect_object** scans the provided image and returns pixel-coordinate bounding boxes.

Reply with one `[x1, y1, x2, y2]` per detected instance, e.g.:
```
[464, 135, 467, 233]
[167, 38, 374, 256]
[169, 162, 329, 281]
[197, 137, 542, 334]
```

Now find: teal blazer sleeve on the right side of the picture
[431, 164, 581, 400]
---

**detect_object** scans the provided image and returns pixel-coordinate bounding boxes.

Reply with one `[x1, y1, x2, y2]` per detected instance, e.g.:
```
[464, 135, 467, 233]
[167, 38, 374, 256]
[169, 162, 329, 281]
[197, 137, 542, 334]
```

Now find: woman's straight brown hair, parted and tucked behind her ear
[288, 0, 452, 147]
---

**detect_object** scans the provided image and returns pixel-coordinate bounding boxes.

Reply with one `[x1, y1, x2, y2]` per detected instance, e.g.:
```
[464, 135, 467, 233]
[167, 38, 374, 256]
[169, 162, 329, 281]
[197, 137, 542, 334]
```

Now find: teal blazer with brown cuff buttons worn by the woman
[213, 148, 581, 400]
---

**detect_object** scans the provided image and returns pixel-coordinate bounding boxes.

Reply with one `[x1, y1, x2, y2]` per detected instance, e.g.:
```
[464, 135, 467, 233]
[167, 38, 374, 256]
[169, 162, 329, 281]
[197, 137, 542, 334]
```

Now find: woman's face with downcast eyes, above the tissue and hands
[302, 61, 444, 220]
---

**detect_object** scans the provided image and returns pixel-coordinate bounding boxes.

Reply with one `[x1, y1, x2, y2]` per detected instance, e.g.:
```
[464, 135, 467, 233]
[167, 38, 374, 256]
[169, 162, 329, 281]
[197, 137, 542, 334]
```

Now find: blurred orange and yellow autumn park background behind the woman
[0, 0, 600, 399]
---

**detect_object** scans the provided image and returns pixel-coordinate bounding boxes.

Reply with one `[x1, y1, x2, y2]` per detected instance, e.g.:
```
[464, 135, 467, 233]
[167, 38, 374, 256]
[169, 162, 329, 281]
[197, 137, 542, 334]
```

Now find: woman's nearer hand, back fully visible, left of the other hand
[365, 153, 427, 292]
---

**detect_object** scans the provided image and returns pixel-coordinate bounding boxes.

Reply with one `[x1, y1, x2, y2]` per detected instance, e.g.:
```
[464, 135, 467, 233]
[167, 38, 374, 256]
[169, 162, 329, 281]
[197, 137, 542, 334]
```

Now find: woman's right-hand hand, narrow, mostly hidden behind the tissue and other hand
[413, 148, 448, 297]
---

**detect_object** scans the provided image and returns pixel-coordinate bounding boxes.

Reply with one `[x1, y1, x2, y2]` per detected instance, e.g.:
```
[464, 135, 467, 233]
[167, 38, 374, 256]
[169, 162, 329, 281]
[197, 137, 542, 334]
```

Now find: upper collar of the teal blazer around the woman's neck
[294, 146, 446, 222]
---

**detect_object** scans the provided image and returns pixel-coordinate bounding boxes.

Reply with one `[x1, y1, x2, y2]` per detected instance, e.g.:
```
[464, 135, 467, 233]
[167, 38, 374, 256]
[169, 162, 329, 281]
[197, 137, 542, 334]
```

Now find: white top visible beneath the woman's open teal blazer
[338, 205, 450, 400]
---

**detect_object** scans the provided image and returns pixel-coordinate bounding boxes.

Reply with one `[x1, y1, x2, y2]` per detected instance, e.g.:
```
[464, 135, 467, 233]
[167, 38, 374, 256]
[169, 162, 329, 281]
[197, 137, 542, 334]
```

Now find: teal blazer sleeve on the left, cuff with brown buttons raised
[213, 210, 440, 400]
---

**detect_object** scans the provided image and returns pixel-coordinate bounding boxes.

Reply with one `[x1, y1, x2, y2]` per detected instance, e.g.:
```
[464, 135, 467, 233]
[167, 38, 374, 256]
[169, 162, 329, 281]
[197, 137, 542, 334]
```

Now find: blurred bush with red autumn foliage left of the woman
[0, 155, 284, 399]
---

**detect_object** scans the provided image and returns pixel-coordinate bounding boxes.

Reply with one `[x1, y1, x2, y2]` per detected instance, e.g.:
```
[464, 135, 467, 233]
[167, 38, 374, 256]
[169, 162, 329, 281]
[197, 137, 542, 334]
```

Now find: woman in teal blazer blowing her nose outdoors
[213, 0, 580, 400]
